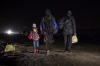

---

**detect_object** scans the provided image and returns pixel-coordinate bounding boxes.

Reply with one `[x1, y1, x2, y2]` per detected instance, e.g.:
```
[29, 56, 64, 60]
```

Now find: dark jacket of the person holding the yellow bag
[63, 16, 76, 35]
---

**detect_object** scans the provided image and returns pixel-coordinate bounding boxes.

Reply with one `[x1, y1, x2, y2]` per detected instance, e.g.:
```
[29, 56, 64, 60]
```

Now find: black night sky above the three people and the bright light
[0, 0, 100, 31]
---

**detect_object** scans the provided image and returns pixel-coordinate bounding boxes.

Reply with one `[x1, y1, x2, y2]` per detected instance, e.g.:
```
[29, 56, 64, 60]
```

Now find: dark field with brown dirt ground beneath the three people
[0, 30, 100, 66]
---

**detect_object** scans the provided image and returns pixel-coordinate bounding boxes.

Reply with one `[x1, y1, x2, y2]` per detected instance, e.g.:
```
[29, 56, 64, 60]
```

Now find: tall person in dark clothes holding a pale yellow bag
[59, 10, 76, 52]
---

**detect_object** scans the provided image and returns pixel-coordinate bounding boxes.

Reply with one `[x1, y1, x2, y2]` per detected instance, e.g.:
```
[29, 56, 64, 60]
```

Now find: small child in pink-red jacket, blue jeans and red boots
[28, 24, 40, 54]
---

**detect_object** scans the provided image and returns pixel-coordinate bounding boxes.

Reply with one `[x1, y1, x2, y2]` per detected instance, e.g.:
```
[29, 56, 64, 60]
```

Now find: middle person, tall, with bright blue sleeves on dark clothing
[40, 9, 58, 54]
